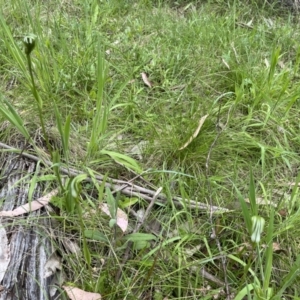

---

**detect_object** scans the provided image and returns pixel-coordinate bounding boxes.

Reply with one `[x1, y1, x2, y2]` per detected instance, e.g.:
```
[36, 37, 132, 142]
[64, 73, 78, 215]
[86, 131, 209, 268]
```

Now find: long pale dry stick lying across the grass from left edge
[0, 142, 229, 212]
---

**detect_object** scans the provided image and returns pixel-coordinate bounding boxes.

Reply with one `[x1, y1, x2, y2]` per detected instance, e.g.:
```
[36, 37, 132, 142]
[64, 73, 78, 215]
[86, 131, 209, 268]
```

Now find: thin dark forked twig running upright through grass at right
[205, 104, 230, 299]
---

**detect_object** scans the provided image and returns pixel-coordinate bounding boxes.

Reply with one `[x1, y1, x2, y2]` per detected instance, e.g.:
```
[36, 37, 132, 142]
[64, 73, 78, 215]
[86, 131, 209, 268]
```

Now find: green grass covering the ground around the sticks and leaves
[0, 0, 300, 299]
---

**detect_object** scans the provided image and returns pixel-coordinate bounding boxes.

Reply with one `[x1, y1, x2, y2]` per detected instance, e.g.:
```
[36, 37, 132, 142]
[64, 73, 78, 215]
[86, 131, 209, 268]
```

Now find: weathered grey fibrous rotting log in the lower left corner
[0, 153, 55, 300]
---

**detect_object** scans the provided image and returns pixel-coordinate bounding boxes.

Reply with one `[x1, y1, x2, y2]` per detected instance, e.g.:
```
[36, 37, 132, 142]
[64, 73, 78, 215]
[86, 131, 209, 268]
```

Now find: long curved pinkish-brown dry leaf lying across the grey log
[0, 189, 58, 217]
